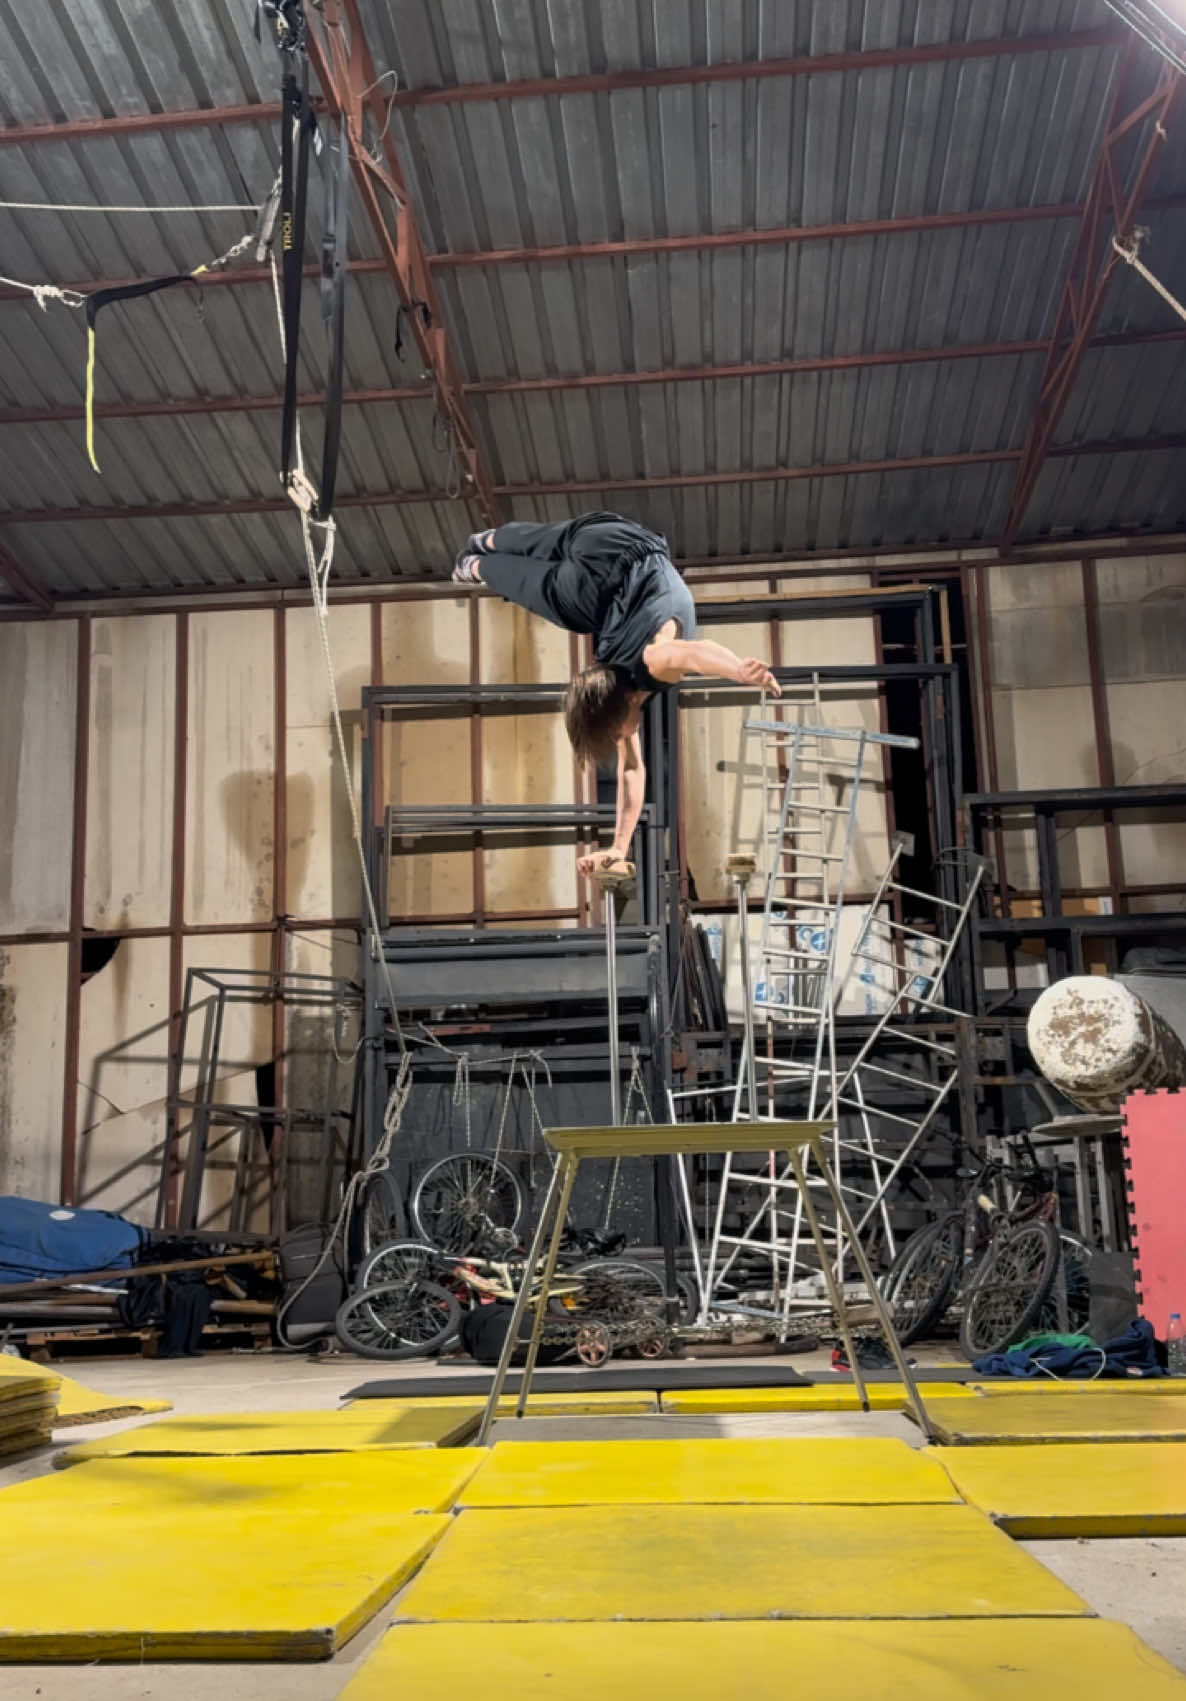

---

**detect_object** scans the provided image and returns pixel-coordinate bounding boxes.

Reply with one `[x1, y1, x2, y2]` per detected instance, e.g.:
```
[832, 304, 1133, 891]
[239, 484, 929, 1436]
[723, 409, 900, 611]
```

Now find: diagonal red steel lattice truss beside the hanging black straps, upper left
[308, 0, 499, 526]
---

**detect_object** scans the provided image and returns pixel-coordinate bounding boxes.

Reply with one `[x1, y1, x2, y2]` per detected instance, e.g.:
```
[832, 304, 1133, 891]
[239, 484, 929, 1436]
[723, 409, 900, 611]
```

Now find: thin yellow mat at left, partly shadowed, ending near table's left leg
[54, 1402, 482, 1465]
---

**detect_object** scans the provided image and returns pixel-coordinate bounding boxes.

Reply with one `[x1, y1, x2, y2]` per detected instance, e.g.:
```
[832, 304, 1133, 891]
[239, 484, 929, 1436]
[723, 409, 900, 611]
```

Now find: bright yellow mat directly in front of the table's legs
[461, 1437, 958, 1507]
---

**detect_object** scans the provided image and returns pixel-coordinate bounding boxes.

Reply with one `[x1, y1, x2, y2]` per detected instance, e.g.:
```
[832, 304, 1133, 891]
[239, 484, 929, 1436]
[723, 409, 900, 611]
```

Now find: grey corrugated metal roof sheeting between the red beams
[0, 0, 1186, 594]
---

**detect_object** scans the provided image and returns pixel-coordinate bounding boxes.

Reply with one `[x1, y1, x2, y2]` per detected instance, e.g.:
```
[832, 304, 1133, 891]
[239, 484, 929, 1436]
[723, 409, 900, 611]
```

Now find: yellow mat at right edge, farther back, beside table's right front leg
[927, 1386, 1186, 1446]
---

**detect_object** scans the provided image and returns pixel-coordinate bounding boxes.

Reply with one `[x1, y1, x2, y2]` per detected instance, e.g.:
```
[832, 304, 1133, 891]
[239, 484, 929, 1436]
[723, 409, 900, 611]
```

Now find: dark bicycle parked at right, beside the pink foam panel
[883, 1155, 1091, 1361]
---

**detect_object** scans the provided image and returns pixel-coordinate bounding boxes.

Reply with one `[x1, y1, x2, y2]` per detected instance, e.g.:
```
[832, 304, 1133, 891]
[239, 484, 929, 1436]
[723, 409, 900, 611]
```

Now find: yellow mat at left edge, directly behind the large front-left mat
[0, 1448, 488, 1527]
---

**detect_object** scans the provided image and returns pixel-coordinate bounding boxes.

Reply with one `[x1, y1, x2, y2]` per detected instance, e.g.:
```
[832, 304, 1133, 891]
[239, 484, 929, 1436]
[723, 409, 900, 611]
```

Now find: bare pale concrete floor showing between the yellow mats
[0, 1352, 1186, 1701]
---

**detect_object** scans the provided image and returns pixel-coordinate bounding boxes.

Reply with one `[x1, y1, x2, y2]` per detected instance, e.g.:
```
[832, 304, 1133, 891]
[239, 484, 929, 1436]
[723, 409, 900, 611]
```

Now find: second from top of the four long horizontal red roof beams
[0, 194, 1186, 306]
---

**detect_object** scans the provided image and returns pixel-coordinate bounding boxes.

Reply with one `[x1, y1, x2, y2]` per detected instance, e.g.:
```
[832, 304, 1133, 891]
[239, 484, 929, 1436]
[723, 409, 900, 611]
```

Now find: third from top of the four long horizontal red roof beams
[0, 328, 1186, 425]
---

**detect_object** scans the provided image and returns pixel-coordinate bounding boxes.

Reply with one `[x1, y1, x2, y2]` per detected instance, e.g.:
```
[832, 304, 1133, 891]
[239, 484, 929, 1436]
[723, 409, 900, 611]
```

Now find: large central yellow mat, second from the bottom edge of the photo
[396, 1505, 1089, 1619]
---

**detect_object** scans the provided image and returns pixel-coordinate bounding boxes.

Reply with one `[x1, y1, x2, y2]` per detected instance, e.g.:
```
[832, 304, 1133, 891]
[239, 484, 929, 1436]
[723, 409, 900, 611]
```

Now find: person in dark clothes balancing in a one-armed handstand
[453, 512, 781, 874]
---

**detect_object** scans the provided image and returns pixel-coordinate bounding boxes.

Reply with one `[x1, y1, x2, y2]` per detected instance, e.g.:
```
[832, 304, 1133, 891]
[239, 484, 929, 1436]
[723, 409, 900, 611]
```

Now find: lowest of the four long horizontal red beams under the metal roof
[0, 434, 1186, 526]
